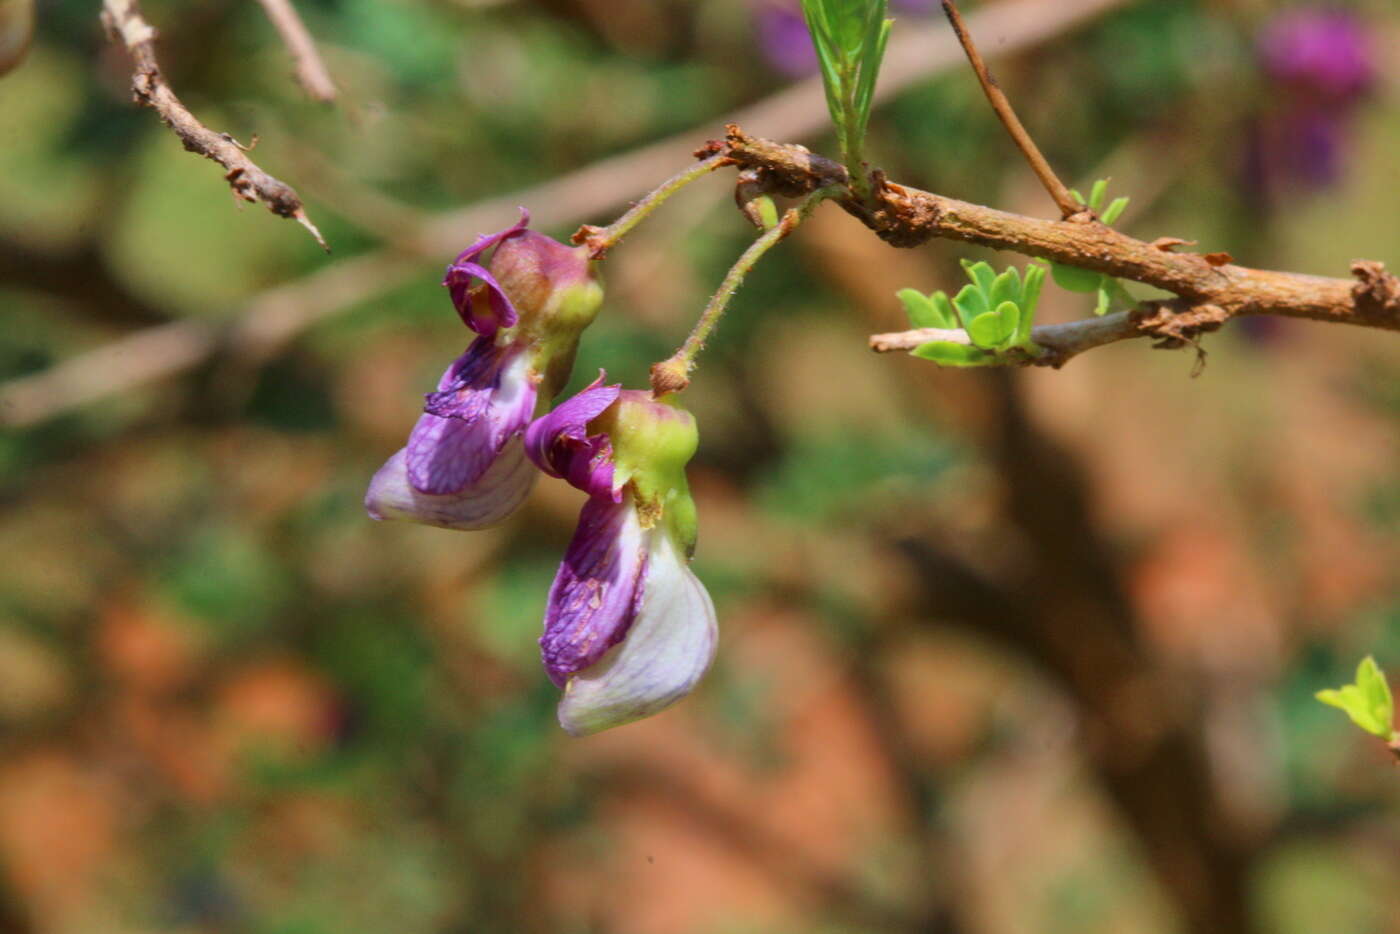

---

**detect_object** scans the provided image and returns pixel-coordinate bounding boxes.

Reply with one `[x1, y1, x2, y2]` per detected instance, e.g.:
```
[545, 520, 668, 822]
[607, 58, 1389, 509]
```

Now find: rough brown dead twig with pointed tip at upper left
[102, 0, 330, 252]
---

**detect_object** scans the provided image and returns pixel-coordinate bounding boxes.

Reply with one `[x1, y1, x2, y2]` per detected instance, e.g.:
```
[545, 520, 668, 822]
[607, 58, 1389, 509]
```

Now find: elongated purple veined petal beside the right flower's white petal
[539, 499, 651, 688]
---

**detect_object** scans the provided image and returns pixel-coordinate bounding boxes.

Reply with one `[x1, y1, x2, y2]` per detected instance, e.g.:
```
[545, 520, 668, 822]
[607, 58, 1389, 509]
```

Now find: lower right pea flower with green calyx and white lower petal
[525, 374, 718, 737]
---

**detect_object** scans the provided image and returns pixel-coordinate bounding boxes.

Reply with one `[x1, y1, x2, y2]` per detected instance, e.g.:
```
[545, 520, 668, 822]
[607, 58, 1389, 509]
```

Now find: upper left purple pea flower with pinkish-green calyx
[365, 209, 602, 529]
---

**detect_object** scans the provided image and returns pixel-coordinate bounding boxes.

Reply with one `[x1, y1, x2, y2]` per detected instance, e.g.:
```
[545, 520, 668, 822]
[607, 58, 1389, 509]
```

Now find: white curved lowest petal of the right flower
[559, 528, 718, 737]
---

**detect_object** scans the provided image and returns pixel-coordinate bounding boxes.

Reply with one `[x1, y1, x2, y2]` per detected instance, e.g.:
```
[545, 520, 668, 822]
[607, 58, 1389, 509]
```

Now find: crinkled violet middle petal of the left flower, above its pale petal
[405, 337, 536, 496]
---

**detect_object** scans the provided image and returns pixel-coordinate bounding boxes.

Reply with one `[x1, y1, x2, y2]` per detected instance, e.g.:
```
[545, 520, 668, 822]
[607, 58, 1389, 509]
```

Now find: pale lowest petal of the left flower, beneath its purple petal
[364, 436, 539, 529]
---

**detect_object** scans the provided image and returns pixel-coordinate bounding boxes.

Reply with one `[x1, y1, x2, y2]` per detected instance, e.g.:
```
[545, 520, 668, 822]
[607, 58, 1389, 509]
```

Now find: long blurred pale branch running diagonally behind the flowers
[0, 0, 1127, 427]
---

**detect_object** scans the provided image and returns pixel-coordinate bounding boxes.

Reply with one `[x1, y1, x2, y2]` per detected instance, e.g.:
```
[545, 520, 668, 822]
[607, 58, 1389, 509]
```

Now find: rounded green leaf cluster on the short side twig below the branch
[899, 260, 1046, 367]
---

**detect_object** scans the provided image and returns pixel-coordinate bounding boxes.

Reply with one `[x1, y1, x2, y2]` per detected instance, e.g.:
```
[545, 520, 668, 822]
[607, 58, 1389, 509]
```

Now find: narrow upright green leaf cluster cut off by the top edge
[802, 0, 895, 193]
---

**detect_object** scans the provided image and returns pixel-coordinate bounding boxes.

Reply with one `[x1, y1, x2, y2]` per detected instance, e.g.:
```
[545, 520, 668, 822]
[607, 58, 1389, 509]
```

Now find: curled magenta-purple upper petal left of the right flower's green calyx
[525, 371, 622, 501]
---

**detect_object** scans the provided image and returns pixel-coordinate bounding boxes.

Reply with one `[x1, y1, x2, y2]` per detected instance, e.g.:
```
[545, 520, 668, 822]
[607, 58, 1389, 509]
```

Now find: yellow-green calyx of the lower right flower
[589, 389, 700, 553]
